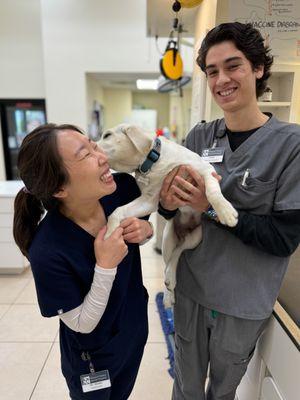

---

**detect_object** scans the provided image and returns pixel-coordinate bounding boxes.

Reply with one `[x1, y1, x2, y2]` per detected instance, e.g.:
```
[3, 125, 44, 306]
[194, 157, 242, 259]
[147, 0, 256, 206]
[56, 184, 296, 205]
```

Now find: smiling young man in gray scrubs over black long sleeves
[159, 22, 300, 400]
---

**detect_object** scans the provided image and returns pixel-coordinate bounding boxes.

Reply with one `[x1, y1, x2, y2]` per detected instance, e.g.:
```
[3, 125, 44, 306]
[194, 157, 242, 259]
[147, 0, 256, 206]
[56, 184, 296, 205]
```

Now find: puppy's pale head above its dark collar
[98, 124, 152, 172]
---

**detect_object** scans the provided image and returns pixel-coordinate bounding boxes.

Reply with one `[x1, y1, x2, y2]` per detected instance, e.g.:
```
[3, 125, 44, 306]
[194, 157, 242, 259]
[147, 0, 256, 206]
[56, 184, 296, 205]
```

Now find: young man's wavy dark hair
[196, 22, 273, 97]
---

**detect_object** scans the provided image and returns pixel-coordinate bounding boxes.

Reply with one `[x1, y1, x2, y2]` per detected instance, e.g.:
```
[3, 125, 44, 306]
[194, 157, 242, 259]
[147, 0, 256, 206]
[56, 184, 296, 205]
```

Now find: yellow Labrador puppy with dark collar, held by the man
[98, 124, 238, 307]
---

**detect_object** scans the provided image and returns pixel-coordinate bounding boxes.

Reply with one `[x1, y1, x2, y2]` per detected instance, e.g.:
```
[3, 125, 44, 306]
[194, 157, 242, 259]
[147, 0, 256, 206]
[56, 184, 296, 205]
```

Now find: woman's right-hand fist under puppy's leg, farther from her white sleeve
[120, 217, 153, 243]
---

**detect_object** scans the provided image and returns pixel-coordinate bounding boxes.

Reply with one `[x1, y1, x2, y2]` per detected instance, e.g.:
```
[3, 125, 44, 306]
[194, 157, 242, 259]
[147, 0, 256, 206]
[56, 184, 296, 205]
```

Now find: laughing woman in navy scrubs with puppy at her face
[14, 124, 153, 400]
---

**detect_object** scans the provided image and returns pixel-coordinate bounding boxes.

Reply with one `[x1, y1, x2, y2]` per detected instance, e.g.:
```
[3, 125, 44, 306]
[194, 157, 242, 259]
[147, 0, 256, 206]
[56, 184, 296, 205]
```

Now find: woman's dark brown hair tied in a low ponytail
[13, 124, 83, 256]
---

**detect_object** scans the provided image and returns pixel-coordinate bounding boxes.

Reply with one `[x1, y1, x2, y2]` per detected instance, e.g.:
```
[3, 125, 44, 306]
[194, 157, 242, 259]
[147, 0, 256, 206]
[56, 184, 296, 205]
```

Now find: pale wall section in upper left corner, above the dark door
[0, 0, 45, 99]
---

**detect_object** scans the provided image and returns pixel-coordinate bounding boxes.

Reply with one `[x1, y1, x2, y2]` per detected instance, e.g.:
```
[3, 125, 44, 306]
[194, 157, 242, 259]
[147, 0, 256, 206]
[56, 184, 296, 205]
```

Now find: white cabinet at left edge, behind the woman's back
[0, 181, 29, 274]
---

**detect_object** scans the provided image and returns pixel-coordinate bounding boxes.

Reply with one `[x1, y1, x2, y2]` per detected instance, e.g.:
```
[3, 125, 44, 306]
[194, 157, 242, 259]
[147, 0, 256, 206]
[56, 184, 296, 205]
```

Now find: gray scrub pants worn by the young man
[172, 291, 269, 400]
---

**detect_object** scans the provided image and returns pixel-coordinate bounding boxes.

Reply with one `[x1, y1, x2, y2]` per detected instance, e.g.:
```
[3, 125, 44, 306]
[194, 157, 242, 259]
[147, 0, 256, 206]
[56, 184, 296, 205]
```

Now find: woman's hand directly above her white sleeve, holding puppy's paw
[94, 226, 128, 269]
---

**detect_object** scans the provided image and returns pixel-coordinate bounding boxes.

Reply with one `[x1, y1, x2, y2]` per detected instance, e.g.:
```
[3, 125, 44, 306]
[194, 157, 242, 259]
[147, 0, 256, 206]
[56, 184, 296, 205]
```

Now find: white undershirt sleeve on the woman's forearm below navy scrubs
[59, 265, 117, 333]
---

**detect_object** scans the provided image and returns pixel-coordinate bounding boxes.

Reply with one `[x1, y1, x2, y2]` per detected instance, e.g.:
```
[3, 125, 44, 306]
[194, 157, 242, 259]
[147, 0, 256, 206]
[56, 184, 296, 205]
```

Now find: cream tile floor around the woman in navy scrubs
[0, 241, 172, 400]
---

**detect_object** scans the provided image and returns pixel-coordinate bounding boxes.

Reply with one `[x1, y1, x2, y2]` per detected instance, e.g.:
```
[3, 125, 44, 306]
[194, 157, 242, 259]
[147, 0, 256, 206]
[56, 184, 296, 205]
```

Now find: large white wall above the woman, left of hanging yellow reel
[41, 0, 186, 128]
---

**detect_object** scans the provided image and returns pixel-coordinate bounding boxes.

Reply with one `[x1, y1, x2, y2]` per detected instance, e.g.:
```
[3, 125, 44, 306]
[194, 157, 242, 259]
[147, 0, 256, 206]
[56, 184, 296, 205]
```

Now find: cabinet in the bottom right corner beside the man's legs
[237, 302, 300, 400]
